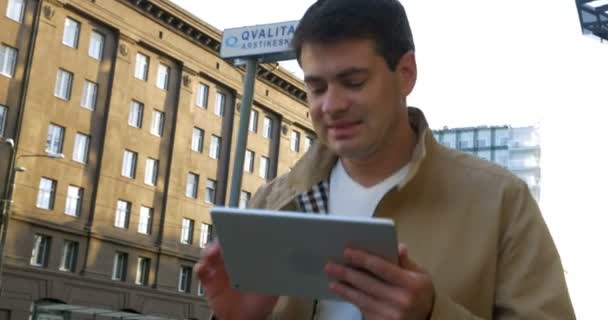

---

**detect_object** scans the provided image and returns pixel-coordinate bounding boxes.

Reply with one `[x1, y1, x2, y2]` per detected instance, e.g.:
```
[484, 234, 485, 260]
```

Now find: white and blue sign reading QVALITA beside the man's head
[220, 20, 299, 63]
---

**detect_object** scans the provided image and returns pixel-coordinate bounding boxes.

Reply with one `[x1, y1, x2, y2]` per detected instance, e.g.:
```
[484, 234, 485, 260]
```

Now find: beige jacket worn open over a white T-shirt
[250, 108, 575, 320]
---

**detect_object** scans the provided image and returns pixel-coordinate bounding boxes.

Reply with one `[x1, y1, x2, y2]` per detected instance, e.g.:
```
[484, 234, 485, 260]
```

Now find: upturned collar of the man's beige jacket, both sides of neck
[287, 107, 434, 194]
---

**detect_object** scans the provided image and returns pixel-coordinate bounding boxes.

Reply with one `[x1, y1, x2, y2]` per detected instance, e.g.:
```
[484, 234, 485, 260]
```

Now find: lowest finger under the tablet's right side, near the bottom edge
[329, 282, 395, 319]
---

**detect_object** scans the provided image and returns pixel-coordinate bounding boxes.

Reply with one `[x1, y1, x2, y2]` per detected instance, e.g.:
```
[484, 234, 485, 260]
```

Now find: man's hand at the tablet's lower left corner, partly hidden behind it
[195, 242, 278, 320]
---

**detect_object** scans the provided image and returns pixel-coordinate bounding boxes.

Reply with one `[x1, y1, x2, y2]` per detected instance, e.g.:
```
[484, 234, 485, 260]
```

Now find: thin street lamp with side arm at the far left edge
[0, 137, 64, 296]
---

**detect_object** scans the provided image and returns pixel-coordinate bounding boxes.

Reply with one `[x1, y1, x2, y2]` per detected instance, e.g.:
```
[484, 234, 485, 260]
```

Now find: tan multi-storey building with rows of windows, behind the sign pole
[0, 0, 313, 320]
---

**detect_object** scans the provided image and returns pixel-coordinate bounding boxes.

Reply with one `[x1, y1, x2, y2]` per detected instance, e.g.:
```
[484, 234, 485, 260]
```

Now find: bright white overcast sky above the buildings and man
[172, 0, 608, 319]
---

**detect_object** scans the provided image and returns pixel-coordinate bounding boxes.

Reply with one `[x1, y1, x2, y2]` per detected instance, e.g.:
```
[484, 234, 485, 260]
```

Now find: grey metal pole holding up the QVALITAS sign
[228, 58, 258, 208]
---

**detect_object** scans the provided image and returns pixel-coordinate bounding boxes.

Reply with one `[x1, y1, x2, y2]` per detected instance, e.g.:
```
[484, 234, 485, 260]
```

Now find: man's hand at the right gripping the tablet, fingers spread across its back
[325, 244, 435, 320]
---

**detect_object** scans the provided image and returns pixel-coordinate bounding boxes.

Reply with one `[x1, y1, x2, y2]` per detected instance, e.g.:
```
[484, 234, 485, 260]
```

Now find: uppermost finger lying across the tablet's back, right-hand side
[344, 249, 406, 286]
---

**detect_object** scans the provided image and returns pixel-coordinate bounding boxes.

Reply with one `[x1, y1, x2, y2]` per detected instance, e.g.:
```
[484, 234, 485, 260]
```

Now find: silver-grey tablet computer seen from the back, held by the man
[211, 207, 399, 300]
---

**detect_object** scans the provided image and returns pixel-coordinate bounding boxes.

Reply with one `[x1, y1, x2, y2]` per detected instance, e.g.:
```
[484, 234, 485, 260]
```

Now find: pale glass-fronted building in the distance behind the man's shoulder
[433, 126, 541, 201]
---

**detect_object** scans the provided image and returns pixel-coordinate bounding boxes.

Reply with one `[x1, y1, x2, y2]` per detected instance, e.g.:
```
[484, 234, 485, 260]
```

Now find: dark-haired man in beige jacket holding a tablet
[197, 0, 574, 320]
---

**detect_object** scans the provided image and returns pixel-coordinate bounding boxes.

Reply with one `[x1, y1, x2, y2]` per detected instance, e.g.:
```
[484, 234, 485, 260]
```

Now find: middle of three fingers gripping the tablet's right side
[325, 262, 405, 304]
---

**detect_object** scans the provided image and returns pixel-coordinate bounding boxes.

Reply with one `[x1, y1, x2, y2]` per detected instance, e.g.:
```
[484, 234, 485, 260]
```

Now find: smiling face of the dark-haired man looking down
[300, 40, 415, 159]
